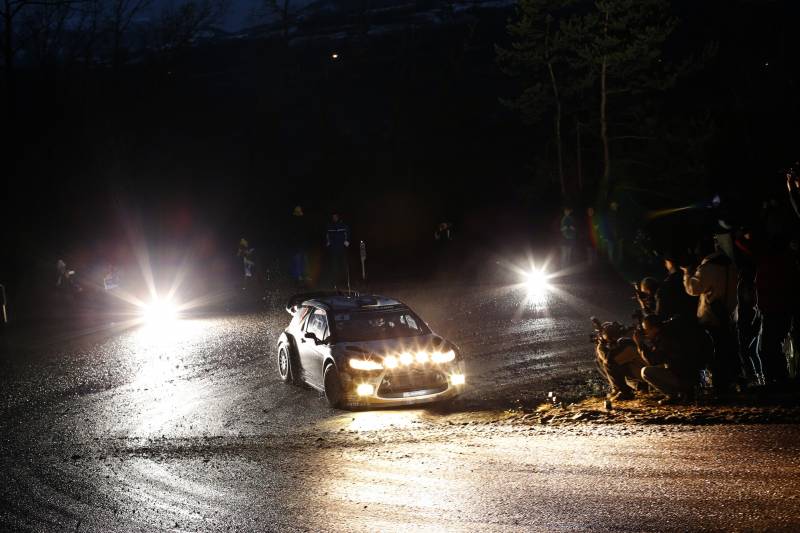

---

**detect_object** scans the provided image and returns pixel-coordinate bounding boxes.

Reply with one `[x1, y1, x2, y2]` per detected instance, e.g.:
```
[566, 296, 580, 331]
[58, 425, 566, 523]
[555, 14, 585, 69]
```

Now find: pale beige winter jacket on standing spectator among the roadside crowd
[683, 252, 739, 327]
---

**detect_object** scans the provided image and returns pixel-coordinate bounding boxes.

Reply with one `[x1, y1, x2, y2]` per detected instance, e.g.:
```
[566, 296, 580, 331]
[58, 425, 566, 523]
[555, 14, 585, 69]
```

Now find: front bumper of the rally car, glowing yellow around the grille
[340, 362, 465, 407]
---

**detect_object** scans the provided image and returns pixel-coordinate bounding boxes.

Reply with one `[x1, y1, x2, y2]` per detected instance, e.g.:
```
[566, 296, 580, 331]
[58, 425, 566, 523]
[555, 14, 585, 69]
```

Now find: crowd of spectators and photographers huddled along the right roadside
[595, 165, 800, 403]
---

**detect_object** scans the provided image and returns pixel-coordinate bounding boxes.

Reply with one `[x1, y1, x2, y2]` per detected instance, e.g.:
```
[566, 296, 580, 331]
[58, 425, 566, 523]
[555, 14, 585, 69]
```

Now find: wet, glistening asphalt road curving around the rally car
[0, 276, 800, 531]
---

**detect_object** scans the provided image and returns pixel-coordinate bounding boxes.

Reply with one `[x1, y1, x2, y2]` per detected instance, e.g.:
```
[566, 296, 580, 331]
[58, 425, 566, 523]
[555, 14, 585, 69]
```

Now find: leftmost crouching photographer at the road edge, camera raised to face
[591, 318, 645, 400]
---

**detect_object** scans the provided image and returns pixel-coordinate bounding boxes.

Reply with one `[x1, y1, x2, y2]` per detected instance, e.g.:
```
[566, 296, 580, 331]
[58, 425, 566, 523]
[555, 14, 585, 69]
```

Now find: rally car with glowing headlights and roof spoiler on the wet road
[277, 292, 465, 408]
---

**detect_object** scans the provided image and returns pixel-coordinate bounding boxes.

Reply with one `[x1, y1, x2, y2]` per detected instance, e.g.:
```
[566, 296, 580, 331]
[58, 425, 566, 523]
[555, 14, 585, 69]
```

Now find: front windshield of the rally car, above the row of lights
[333, 310, 428, 342]
